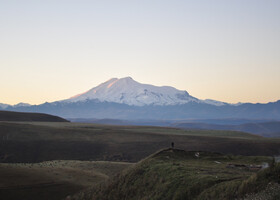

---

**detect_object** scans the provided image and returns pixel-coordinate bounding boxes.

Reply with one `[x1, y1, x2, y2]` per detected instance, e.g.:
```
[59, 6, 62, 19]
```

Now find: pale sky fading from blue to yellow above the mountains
[0, 0, 280, 104]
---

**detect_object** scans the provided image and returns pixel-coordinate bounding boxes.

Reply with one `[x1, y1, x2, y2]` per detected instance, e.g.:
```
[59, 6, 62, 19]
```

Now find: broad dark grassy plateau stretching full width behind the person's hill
[0, 122, 280, 163]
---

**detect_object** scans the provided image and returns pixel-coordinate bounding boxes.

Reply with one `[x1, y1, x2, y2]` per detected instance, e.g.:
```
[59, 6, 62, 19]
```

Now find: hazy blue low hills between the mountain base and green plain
[69, 118, 280, 137]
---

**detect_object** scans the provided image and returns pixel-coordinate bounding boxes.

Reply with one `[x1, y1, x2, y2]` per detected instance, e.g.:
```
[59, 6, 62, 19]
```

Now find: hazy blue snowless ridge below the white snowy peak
[2, 99, 280, 120]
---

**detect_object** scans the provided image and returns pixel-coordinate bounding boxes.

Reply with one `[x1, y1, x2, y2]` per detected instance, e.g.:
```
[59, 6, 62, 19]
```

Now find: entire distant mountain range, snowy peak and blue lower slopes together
[0, 77, 280, 120]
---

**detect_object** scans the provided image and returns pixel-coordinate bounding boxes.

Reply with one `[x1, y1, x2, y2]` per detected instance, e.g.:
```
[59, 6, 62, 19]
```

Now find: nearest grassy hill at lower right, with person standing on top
[71, 149, 280, 200]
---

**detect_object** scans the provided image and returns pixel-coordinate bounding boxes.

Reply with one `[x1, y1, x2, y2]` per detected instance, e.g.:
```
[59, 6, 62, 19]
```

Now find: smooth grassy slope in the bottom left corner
[0, 160, 131, 200]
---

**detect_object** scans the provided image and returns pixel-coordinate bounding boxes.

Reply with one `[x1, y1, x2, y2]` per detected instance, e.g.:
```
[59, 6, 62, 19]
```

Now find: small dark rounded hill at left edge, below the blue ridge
[0, 111, 68, 122]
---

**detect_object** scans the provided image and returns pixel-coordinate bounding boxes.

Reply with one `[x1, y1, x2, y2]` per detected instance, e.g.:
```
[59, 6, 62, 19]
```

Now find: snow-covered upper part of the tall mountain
[66, 77, 201, 106]
